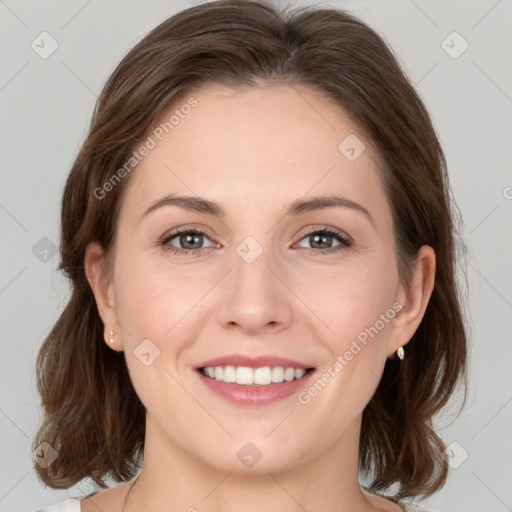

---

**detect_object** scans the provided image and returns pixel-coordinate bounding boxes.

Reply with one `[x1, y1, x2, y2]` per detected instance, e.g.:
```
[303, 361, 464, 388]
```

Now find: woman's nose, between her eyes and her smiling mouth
[217, 240, 293, 335]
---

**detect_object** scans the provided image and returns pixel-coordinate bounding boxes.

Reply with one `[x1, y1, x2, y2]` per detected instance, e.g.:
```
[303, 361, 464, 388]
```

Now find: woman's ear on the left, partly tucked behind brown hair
[84, 242, 122, 352]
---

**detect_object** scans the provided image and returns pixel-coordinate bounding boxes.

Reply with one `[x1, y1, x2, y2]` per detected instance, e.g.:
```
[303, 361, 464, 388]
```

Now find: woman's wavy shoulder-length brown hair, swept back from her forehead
[33, 0, 467, 497]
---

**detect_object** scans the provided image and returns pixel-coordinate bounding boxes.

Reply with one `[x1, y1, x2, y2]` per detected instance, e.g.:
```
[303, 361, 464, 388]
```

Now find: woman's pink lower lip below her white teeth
[197, 370, 315, 405]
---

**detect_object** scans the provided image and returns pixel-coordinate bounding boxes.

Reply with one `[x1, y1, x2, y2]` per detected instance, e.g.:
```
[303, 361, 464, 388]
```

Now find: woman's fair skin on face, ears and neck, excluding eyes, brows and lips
[82, 85, 435, 512]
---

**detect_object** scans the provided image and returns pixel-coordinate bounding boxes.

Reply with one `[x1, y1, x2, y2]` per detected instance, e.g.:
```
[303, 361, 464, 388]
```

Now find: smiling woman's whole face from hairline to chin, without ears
[90, 86, 422, 472]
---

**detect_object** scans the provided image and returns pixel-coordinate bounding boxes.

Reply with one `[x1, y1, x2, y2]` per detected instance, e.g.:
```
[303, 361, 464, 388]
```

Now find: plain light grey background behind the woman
[0, 0, 512, 512]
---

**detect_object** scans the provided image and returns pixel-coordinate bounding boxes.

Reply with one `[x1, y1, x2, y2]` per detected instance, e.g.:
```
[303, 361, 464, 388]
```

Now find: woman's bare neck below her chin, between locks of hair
[125, 415, 376, 512]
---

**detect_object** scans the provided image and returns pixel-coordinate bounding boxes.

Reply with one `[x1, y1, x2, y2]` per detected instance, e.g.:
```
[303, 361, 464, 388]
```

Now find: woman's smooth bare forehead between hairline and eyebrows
[118, 85, 382, 218]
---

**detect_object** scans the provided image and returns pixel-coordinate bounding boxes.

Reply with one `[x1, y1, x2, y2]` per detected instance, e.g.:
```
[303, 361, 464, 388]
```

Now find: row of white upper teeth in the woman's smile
[203, 366, 306, 386]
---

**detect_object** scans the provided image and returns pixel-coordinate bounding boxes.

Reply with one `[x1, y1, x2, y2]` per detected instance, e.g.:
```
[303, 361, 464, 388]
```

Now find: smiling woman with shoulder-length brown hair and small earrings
[34, 0, 466, 512]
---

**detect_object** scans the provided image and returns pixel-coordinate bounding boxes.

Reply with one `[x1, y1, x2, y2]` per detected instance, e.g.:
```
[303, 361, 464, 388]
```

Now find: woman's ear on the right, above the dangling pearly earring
[387, 245, 436, 357]
